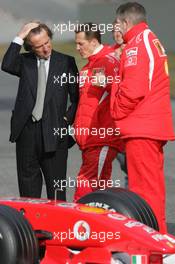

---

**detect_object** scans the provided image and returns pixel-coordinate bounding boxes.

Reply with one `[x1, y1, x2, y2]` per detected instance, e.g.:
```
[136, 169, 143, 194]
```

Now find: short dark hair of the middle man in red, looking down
[75, 22, 101, 44]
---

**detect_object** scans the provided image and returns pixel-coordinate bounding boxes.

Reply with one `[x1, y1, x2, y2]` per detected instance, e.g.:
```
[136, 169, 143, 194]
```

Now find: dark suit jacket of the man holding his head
[1, 43, 78, 151]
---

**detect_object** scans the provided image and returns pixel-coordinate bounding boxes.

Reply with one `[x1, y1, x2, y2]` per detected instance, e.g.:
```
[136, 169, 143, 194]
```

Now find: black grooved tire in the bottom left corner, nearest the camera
[0, 205, 39, 264]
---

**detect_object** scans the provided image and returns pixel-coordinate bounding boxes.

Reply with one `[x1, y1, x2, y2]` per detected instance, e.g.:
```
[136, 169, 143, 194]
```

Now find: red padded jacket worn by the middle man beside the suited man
[74, 46, 123, 151]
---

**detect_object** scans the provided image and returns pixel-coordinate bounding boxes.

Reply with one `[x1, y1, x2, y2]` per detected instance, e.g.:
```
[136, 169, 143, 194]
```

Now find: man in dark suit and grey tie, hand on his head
[2, 22, 78, 200]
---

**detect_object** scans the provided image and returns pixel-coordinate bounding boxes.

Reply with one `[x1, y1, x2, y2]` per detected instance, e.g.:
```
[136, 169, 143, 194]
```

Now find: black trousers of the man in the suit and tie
[16, 120, 68, 200]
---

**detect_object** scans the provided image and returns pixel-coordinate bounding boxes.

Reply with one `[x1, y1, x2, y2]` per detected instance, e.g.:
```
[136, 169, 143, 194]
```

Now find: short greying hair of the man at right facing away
[116, 2, 146, 25]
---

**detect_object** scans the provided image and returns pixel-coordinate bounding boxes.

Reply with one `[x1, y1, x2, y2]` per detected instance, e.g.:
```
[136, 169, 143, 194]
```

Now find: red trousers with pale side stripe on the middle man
[74, 146, 117, 201]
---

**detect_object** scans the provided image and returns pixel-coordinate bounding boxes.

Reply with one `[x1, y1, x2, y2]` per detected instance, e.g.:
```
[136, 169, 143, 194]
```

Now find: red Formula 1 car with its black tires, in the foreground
[0, 188, 175, 264]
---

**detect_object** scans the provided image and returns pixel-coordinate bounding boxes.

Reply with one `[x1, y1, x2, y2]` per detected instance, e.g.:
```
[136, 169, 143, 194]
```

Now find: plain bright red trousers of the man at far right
[126, 138, 167, 233]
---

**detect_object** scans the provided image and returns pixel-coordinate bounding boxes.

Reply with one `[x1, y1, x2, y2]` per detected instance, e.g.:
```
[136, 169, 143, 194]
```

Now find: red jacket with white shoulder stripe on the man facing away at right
[111, 23, 175, 140]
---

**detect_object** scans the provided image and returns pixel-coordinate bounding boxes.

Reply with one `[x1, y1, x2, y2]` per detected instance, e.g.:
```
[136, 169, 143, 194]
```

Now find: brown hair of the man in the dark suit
[23, 23, 53, 51]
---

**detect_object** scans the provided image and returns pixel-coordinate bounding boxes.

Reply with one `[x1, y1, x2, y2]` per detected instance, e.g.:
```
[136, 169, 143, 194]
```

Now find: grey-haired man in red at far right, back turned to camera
[111, 2, 175, 233]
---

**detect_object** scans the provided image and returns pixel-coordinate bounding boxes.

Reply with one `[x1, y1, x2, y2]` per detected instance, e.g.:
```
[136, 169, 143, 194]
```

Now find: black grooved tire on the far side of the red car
[77, 188, 159, 231]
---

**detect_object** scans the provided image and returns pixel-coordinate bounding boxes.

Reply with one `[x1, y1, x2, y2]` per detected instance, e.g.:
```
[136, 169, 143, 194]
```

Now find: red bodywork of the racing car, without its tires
[0, 197, 175, 264]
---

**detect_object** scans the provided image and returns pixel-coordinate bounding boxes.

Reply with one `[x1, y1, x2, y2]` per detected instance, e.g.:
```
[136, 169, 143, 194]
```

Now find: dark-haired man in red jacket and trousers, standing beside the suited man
[74, 23, 123, 200]
